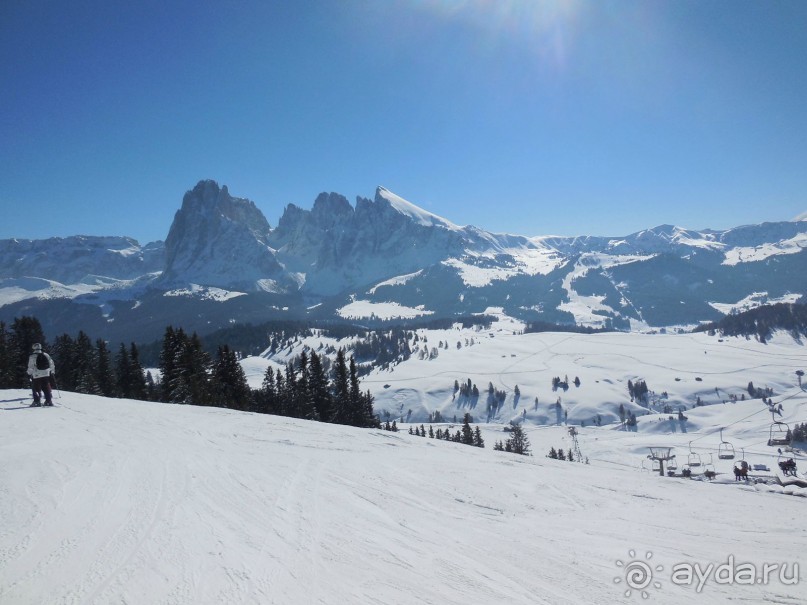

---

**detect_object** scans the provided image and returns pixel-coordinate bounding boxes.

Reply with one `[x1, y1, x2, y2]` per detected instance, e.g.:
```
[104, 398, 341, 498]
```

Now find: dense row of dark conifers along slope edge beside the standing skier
[0, 317, 380, 427]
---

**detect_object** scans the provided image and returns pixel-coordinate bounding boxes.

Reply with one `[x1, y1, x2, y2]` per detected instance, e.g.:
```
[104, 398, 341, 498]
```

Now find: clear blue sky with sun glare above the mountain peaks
[0, 0, 807, 243]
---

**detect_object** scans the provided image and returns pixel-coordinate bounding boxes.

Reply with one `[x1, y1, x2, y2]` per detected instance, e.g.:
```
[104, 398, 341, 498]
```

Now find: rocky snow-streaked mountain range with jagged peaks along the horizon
[0, 180, 807, 342]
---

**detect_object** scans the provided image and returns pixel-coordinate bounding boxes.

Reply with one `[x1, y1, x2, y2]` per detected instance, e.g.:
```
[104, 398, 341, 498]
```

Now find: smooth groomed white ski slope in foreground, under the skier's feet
[0, 382, 807, 605]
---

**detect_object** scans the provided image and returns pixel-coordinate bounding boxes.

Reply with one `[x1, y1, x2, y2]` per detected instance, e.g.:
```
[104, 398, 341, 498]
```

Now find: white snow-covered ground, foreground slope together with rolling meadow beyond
[0, 318, 807, 605]
